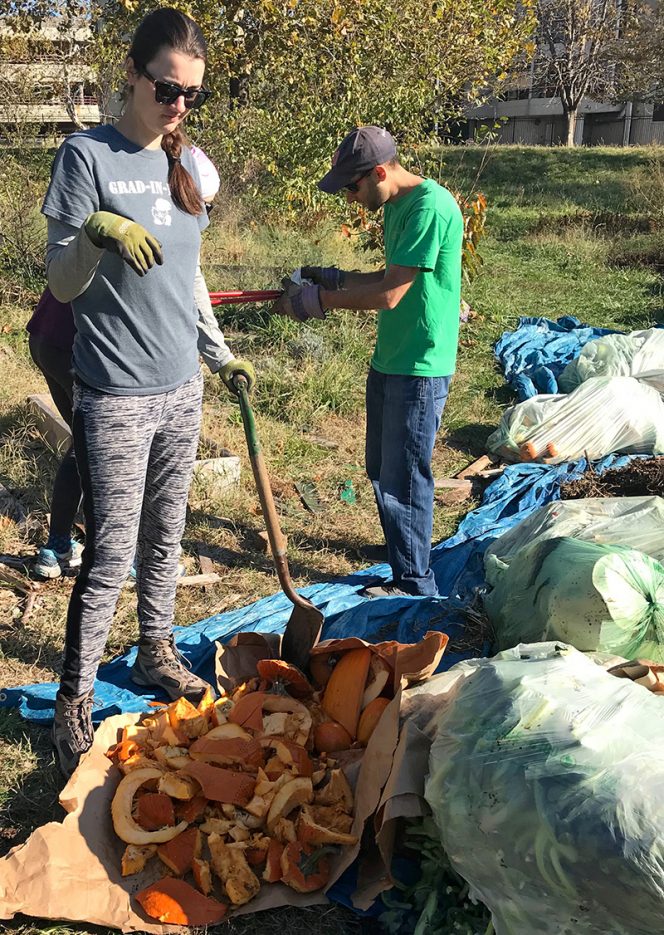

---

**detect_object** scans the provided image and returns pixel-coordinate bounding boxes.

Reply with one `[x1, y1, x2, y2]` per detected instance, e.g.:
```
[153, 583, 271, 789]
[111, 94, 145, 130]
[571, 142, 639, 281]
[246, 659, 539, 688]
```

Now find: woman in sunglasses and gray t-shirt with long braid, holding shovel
[42, 8, 253, 775]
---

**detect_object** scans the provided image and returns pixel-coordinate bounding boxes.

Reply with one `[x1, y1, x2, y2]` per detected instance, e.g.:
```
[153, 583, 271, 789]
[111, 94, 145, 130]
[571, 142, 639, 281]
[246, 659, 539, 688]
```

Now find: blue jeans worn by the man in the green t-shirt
[365, 368, 451, 597]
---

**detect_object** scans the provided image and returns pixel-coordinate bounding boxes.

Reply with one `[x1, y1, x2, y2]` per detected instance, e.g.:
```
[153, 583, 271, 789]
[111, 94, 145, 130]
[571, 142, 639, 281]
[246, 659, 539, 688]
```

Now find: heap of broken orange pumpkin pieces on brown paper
[106, 650, 389, 925]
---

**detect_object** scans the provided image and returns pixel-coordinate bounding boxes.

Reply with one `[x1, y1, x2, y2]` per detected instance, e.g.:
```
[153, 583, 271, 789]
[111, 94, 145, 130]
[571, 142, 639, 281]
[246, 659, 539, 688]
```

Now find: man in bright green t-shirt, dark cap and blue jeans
[276, 126, 463, 597]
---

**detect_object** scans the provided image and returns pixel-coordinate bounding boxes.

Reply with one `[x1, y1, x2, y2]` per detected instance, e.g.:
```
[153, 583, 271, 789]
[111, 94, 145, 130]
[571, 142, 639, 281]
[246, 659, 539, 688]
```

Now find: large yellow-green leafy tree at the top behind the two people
[90, 0, 533, 211]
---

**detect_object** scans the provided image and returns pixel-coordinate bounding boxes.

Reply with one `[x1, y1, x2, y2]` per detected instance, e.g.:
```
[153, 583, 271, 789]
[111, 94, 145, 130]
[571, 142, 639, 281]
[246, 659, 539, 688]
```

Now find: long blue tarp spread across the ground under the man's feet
[0, 455, 630, 722]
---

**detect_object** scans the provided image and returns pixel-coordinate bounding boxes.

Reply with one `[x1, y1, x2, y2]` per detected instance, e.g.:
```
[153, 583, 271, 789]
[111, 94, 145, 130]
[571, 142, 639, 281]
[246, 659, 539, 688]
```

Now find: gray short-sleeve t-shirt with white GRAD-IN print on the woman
[42, 125, 208, 396]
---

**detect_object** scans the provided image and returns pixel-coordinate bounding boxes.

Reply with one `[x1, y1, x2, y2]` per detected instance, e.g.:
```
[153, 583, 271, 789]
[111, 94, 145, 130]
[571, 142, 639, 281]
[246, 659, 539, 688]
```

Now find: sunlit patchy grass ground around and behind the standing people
[0, 148, 664, 935]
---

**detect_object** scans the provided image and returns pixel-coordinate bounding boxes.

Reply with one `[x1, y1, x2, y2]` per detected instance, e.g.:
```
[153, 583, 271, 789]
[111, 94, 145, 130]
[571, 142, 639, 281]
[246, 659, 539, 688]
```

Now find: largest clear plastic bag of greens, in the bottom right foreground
[425, 643, 664, 935]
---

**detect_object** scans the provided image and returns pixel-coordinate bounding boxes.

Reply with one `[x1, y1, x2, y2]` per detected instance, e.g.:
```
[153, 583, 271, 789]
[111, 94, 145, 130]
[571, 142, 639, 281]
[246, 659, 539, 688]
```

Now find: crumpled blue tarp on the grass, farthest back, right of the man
[494, 315, 624, 400]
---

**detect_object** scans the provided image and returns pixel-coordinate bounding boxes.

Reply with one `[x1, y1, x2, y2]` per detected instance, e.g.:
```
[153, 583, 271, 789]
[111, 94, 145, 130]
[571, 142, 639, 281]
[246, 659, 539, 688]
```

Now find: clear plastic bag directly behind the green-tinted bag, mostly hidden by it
[484, 497, 664, 572]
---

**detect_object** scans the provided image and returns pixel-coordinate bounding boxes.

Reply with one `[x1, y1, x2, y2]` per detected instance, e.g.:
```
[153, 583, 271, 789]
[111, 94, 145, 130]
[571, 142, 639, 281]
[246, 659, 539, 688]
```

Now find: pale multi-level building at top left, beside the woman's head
[0, 21, 103, 142]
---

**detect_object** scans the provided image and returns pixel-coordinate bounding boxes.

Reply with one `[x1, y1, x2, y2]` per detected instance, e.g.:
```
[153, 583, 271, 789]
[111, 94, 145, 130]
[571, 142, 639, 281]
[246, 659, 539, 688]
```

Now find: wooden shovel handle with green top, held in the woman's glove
[233, 374, 311, 608]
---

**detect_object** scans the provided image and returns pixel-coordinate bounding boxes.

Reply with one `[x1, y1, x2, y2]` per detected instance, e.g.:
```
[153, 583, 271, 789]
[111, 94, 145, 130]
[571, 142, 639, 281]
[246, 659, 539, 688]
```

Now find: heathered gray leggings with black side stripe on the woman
[60, 371, 203, 697]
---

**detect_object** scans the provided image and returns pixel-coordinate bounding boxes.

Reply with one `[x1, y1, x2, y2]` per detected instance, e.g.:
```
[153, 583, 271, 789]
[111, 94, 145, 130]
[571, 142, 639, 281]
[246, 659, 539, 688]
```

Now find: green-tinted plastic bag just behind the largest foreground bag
[484, 537, 664, 660]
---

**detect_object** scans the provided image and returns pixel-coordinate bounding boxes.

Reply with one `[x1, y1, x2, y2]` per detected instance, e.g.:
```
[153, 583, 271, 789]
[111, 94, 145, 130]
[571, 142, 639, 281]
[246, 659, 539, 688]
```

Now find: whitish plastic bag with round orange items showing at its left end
[487, 377, 664, 464]
